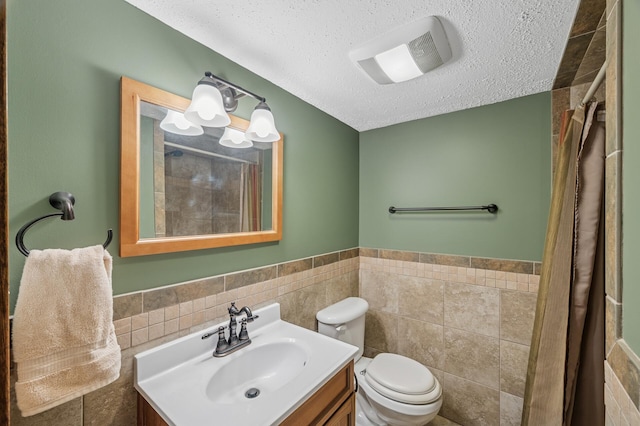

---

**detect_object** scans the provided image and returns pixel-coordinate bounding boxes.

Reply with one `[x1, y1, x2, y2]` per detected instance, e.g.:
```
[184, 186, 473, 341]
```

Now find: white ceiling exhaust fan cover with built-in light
[349, 16, 452, 84]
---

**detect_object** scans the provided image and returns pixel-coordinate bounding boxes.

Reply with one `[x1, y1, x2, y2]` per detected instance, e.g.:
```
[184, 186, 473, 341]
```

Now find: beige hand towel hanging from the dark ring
[13, 246, 120, 417]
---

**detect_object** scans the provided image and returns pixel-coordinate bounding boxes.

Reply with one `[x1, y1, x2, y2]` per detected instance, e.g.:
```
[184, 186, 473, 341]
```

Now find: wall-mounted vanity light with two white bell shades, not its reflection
[184, 71, 280, 142]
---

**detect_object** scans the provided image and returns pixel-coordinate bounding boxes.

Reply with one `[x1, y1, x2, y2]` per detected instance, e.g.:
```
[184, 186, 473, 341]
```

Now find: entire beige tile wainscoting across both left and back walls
[11, 248, 568, 426]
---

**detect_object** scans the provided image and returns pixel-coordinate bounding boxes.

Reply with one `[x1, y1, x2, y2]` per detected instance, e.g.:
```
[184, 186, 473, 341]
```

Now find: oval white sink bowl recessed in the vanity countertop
[206, 339, 309, 404]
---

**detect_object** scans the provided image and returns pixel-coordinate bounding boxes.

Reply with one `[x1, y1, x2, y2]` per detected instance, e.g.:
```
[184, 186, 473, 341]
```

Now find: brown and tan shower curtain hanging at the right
[522, 102, 605, 426]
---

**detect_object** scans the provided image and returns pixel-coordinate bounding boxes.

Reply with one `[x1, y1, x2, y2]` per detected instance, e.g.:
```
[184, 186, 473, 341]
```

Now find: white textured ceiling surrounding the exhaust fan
[126, 0, 579, 131]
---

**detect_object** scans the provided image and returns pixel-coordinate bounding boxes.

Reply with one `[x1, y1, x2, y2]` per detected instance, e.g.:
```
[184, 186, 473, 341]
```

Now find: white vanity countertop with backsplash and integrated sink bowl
[134, 303, 358, 426]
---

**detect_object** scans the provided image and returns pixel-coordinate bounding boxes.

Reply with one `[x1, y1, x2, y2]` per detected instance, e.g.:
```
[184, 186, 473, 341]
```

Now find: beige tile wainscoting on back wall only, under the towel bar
[360, 249, 540, 426]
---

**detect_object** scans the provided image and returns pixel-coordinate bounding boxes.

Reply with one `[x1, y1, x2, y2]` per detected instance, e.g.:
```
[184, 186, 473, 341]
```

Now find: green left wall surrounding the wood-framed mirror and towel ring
[7, 0, 358, 312]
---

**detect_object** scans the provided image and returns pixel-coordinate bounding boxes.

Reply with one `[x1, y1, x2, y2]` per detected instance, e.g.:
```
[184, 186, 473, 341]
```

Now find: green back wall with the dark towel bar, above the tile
[360, 93, 551, 260]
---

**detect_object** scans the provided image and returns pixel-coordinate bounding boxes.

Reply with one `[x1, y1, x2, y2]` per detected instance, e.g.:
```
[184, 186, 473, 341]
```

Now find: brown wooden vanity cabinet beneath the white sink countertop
[138, 361, 356, 426]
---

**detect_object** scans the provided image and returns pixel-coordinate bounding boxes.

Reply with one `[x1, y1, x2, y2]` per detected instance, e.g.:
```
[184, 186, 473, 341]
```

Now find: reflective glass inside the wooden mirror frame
[140, 101, 272, 238]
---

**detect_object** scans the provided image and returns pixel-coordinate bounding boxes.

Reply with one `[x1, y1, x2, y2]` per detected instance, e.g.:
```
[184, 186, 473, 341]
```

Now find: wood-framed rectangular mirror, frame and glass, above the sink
[120, 77, 284, 257]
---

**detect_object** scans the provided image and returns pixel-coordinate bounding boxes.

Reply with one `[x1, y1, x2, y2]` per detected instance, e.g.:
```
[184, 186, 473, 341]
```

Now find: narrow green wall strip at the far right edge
[622, 0, 640, 354]
